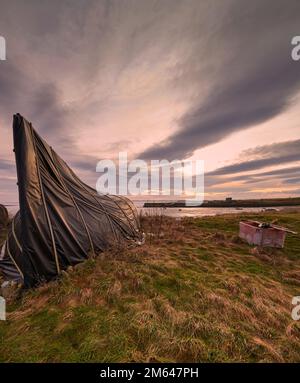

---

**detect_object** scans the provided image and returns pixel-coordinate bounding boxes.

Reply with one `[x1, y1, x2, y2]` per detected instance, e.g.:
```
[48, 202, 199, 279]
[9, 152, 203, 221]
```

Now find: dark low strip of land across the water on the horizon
[143, 198, 300, 208]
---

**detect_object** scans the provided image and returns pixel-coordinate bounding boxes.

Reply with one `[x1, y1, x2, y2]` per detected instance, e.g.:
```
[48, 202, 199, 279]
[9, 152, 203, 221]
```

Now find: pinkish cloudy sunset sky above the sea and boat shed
[0, 0, 300, 203]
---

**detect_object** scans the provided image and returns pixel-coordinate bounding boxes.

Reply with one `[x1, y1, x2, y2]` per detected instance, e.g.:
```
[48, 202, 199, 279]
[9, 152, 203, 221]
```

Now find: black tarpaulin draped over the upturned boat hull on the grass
[0, 114, 143, 287]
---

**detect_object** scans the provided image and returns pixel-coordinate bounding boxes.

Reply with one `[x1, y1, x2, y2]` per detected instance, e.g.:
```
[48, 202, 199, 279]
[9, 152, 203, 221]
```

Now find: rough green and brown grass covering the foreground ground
[0, 212, 300, 362]
